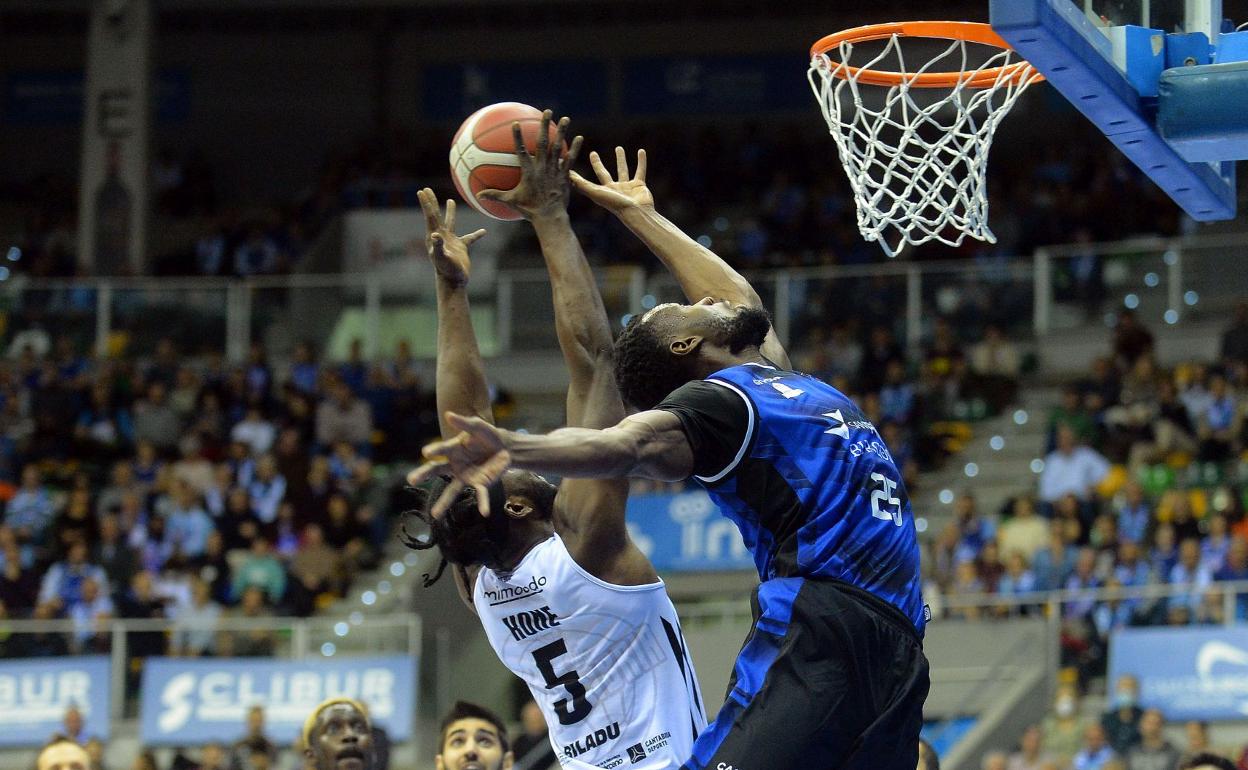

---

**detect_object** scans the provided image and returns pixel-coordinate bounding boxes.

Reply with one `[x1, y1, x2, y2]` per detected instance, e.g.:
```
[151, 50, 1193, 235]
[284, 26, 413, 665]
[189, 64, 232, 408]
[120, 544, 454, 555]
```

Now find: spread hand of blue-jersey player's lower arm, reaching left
[407, 412, 512, 518]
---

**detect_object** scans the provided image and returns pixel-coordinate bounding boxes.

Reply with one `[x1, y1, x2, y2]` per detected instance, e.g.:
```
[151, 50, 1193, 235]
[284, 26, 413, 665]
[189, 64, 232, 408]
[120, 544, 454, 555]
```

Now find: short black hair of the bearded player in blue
[615, 312, 693, 411]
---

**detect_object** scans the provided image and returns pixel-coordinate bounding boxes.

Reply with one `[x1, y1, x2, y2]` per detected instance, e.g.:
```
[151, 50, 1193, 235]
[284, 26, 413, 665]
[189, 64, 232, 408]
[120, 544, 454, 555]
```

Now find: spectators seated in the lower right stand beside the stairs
[925, 305, 1248, 681]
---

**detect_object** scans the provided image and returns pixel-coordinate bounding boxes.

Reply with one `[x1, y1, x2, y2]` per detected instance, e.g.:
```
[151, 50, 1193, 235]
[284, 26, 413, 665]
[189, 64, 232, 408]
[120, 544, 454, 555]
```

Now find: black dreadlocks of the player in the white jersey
[402, 470, 558, 588]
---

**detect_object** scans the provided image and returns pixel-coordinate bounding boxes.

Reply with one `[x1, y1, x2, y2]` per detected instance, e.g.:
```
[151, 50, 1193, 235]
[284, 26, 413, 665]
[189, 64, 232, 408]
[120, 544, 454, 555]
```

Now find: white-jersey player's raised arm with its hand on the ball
[479, 110, 656, 583]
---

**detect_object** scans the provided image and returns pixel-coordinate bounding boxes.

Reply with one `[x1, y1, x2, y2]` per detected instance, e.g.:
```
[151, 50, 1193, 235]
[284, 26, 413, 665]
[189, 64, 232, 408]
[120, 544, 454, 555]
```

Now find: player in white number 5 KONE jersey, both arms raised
[409, 111, 706, 770]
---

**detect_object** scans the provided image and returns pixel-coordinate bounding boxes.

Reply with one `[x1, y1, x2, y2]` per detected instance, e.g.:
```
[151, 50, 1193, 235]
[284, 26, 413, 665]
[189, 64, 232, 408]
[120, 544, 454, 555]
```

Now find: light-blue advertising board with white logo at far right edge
[1109, 626, 1248, 721]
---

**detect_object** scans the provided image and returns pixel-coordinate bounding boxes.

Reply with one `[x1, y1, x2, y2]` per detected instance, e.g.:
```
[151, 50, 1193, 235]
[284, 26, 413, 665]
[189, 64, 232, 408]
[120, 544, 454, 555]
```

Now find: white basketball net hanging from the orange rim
[807, 35, 1041, 257]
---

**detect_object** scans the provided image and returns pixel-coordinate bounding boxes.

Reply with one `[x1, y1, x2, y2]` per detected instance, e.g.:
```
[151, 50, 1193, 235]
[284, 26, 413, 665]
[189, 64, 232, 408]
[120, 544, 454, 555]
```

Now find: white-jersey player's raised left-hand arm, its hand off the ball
[417, 187, 493, 612]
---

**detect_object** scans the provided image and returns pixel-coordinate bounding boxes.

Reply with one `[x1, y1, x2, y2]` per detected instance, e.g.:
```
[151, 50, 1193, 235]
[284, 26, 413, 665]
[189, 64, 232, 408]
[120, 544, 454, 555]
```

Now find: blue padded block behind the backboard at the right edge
[1157, 61, 1248, 161]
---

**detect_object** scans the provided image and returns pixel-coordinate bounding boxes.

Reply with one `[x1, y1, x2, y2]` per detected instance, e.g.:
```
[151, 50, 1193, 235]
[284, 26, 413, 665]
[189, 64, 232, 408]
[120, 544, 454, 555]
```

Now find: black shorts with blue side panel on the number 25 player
[684, 578, 929, 770]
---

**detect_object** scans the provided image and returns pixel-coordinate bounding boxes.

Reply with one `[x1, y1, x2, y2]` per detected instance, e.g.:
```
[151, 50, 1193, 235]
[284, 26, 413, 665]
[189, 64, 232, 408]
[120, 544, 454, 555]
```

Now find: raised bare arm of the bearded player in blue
[572, 147, 790, 368]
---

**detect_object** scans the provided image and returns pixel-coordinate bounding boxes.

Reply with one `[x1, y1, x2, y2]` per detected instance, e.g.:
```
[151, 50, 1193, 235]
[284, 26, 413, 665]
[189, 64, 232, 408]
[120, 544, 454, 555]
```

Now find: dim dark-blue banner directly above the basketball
[424, 60, 608, 120]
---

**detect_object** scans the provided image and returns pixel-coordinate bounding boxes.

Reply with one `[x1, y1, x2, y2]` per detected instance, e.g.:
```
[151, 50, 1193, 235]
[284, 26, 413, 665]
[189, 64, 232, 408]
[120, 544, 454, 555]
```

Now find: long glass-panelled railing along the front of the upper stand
[0, 228, 1248, 361]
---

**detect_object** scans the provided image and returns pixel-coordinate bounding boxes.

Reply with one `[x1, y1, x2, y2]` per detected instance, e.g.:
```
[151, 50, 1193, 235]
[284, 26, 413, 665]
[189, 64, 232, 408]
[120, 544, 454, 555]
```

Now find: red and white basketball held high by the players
[451, 101, 568, 221]
